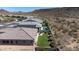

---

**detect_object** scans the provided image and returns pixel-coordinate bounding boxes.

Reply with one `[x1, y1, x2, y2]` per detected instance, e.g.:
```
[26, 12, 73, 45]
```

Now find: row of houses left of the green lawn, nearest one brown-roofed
[0, 18, 42, 46]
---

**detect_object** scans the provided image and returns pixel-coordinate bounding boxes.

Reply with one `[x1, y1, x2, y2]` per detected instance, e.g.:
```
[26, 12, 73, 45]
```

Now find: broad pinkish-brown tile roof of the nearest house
[0, 27, 37, 40]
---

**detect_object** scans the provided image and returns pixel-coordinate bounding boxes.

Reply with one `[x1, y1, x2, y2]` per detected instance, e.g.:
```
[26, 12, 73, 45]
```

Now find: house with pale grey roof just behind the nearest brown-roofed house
[17, 18, 42, 30]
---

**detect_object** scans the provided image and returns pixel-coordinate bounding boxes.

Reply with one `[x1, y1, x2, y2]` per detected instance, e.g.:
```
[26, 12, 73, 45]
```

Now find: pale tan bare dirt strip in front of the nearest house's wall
[0, 45, 34, 51]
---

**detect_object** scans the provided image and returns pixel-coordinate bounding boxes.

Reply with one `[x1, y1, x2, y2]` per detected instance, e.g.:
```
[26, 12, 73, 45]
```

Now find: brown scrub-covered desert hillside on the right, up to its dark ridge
[32, 7, 79, 51]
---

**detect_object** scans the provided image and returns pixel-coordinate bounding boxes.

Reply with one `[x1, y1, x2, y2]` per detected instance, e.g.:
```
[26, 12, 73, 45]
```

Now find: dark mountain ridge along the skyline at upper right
[33, 7, 79, 18]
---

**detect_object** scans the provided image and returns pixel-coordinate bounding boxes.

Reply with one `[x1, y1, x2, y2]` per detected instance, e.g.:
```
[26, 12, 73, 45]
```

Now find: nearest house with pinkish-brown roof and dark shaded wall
[0, 27, 37, 46]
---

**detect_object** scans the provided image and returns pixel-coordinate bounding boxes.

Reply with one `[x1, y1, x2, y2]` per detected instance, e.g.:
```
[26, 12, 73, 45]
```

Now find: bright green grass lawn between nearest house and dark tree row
[37, 33, 50, 48]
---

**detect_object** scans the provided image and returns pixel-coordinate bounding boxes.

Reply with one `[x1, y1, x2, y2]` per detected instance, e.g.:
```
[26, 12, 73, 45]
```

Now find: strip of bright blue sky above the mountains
[0, 7, 48, 12]
